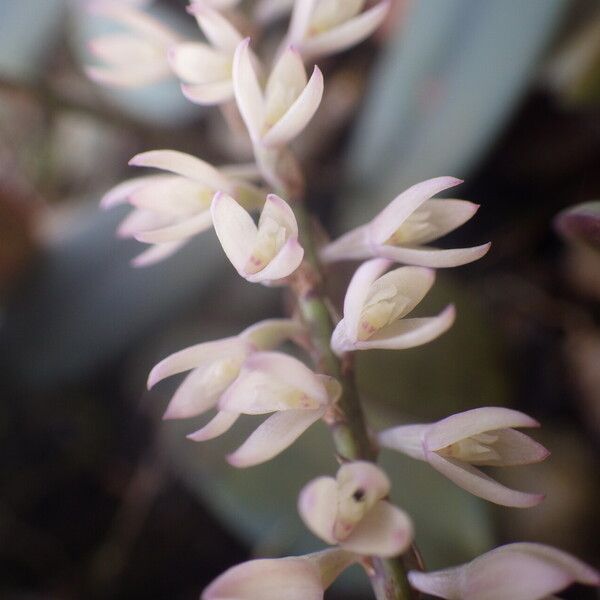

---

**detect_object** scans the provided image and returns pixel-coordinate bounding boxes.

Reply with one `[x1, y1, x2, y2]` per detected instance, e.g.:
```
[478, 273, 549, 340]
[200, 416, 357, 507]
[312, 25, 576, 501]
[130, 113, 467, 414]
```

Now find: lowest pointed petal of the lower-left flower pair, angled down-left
[227, 409, 325, 468]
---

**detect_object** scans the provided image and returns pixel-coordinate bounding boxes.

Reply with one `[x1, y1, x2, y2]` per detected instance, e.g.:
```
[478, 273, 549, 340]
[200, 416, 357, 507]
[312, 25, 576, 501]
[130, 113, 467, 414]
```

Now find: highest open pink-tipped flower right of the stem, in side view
[321, 177, 490, 268]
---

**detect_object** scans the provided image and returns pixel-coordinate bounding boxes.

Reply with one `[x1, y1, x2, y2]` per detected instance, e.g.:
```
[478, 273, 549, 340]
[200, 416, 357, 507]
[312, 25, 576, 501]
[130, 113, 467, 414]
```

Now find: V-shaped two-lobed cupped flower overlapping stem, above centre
[211, 193, 304, 284]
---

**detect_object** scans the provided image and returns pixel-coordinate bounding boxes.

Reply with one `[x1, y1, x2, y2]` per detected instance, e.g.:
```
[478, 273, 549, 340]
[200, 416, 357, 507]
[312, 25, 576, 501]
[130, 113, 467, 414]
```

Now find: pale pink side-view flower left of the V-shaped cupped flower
[100, 150, 262, 266]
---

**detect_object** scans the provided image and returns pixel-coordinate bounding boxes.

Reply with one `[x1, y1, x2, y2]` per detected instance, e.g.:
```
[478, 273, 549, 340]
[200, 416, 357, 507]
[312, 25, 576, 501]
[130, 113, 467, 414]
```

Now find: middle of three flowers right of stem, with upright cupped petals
[331, 258, 455, 355]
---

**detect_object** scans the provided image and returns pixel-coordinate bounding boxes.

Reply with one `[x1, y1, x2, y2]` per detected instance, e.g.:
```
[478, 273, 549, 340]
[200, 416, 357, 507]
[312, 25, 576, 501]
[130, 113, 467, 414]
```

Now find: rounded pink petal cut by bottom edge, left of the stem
[201, 558, 323, 600]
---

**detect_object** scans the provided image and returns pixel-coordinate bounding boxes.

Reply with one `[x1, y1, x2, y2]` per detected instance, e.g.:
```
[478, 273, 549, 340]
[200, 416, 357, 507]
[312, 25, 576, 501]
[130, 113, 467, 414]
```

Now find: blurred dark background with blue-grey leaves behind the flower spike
[0, 0, 600, 599]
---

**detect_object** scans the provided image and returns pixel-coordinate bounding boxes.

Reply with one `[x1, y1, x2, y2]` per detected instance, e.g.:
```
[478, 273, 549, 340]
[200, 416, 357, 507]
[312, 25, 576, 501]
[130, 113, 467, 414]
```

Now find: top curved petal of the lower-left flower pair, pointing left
[148, 336, 244, 389]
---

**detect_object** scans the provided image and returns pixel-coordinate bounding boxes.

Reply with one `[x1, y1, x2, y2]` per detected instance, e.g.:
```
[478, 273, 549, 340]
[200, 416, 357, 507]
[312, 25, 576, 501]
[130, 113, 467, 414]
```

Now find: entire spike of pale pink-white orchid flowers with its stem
[88, 0, 599, 600]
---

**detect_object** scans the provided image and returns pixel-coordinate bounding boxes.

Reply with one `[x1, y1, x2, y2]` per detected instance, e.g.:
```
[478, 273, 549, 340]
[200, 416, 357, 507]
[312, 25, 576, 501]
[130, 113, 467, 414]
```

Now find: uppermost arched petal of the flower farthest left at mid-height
[129, 150, 231, 191]
